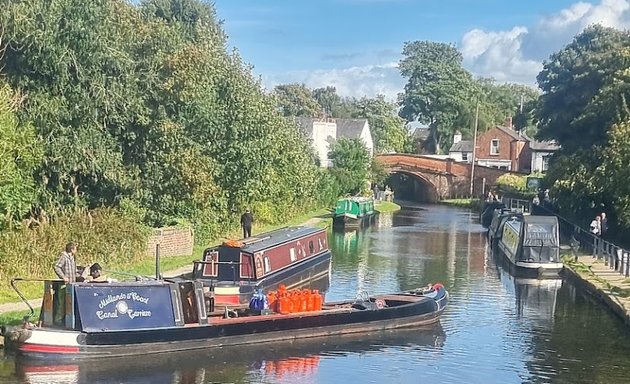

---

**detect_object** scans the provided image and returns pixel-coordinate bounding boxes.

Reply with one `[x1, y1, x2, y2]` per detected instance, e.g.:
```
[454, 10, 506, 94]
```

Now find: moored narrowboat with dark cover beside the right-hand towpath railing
[497, 215, 564, 278]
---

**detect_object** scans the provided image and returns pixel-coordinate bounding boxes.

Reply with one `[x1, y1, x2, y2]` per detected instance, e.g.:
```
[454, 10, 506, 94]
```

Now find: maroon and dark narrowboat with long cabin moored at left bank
[192, 226, 331, 305]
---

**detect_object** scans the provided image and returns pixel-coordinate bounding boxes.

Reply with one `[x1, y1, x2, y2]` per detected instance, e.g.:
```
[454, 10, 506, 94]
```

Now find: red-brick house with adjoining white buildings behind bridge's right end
[449, 119, 559, 173]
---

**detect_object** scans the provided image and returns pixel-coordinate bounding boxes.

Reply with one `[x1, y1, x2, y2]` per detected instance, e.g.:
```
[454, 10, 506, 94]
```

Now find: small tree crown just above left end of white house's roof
[273, 84, 322, 117]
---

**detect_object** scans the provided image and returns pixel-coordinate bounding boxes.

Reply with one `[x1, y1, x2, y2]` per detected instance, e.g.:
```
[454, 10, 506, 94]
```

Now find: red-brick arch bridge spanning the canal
[376, 153, 523, 203]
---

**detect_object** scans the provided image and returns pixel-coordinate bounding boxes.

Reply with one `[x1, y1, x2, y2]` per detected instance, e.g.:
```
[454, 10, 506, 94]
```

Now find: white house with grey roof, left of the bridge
[293, 117, 374, 167]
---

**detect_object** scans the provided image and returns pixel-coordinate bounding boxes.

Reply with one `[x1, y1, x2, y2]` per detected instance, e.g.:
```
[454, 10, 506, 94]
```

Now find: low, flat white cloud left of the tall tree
[263, 62, 405, 100]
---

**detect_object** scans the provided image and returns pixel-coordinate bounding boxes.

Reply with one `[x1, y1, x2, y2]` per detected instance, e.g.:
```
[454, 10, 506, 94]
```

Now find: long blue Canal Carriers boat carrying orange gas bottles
[2, 279, 448, 362]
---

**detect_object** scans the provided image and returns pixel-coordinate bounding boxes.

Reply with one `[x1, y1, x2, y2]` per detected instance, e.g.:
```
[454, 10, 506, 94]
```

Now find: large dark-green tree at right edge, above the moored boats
[536, 25, 630, 153]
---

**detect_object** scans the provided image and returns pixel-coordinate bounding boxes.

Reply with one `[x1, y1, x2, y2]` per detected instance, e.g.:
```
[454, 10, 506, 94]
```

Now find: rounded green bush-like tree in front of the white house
[328, 138, 370, 194]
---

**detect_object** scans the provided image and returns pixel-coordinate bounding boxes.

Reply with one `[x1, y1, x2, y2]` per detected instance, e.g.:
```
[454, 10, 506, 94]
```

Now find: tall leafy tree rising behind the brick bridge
[399, 41, 478, 153]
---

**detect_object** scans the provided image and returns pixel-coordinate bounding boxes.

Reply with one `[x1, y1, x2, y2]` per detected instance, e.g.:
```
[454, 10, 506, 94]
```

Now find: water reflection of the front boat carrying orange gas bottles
[16, 323, 446, 384]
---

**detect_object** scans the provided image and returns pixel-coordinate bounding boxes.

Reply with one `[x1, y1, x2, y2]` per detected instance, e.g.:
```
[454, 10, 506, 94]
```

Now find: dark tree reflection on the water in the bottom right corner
[527, 283, 630, 384]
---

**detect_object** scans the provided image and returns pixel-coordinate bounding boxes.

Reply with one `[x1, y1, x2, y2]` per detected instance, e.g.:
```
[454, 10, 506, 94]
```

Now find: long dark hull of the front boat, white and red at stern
[8, 288, 448, 361]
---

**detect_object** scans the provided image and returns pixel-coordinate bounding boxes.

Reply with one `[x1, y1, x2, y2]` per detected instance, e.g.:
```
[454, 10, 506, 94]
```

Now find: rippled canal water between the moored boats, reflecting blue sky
[0, 205, 630, 384]
